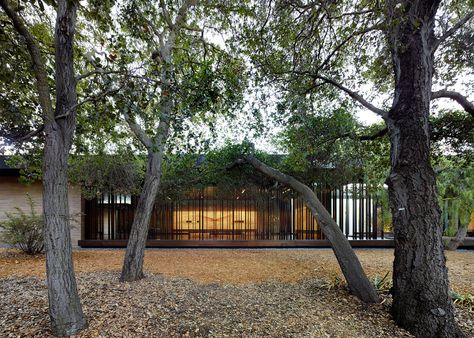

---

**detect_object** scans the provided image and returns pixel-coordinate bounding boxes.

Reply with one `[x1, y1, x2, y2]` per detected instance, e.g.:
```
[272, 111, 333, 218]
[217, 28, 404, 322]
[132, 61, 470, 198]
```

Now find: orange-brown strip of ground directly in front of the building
[0, 249, 474, 295]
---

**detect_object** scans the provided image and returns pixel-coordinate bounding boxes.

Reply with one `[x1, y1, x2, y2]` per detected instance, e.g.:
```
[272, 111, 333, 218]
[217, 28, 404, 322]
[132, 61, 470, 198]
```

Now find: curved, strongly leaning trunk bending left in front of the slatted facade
[241, 156, 379, 303]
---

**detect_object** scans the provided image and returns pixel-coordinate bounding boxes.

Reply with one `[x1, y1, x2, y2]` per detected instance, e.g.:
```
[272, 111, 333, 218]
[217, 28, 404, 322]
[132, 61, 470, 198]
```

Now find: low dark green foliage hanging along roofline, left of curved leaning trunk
[69, 143, 283, 199]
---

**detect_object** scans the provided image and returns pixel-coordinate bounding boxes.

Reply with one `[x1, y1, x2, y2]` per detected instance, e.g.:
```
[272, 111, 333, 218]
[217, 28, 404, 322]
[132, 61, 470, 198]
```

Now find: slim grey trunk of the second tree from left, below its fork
[120, 149, 163, 282]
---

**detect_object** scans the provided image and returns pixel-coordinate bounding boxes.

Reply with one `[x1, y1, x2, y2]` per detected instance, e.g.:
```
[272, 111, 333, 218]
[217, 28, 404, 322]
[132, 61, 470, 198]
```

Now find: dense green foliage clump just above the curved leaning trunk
[280, 108, 361, 185]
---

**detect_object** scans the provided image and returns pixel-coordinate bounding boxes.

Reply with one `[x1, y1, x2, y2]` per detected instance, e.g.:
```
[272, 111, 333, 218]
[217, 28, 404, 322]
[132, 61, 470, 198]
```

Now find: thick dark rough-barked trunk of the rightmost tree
[385, 0, 463, 337]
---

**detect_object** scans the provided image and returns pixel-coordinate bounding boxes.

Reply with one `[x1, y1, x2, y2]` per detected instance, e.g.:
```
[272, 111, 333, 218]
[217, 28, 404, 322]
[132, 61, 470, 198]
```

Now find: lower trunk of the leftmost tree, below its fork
[43, 134, 87, 336]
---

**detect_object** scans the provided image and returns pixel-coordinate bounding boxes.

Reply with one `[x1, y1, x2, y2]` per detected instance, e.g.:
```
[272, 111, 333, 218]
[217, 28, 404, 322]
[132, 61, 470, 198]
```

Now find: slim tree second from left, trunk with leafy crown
[117, 0, 243, 281]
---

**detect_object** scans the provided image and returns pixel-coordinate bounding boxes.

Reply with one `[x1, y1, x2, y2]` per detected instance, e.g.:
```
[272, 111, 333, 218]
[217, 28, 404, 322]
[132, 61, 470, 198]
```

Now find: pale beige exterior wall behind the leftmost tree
[0, 176, 82, 247]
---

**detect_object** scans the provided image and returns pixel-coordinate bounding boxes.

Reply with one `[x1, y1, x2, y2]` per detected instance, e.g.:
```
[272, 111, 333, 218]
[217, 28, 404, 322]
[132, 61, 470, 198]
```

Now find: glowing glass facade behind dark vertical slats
[84, 184, 383, 240]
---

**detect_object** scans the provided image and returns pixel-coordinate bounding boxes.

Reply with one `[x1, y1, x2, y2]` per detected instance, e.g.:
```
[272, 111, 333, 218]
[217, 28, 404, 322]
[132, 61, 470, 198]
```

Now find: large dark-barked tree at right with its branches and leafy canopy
[241, 0, 474, 337]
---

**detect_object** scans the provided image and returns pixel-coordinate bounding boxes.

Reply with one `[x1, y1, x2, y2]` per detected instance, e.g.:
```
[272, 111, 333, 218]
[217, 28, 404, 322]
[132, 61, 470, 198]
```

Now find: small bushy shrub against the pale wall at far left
[0, 194, 44, 255]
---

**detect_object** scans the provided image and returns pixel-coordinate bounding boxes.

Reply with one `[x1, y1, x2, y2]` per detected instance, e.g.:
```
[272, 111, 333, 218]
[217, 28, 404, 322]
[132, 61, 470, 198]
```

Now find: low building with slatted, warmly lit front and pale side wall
[0, 158, 474, 247]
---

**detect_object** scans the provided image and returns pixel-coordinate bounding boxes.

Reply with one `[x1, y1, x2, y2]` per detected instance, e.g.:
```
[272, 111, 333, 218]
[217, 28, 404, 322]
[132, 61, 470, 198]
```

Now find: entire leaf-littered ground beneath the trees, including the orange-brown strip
[0, 249, 474, 337]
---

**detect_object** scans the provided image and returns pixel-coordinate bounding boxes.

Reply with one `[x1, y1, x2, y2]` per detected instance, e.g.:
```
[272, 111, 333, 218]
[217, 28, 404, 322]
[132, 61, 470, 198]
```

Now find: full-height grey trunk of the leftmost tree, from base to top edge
[43, 0, 87, 336]
